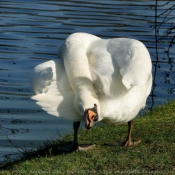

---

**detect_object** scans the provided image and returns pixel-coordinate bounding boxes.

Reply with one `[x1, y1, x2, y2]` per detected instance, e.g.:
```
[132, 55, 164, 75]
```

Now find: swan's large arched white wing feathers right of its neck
[87, 38, 152, 97]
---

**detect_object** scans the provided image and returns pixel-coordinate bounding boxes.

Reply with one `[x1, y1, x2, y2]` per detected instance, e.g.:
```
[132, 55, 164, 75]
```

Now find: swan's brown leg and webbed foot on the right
[123, 120, 141, 147]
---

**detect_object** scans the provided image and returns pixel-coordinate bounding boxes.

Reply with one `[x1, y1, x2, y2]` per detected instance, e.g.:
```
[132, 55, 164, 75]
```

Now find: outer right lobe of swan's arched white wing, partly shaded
[107, 38, 152, 89]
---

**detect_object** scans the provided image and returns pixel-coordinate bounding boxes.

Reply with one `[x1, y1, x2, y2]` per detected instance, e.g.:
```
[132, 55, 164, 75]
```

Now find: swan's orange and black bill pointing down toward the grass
[84, 104, 98, 129]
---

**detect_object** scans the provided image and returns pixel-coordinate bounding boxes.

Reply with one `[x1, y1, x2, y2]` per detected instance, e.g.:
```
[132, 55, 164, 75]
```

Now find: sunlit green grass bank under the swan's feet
[0, 102, 175, 175]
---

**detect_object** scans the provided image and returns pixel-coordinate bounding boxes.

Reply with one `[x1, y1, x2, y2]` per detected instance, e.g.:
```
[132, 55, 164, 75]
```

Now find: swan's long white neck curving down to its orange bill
[62, 33, 100, 115]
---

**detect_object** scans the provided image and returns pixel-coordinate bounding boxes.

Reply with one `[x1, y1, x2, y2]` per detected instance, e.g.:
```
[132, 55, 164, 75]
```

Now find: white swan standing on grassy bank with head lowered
[30, 33, 152, 150]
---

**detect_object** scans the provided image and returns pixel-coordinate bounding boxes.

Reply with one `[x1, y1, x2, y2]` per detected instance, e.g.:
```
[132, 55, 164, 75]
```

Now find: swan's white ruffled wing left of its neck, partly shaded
[30, 59, 81, 121]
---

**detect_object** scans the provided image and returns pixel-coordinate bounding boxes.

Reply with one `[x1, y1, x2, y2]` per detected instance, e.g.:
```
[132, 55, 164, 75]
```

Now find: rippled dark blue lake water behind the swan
[0, 0, 175, 162]
